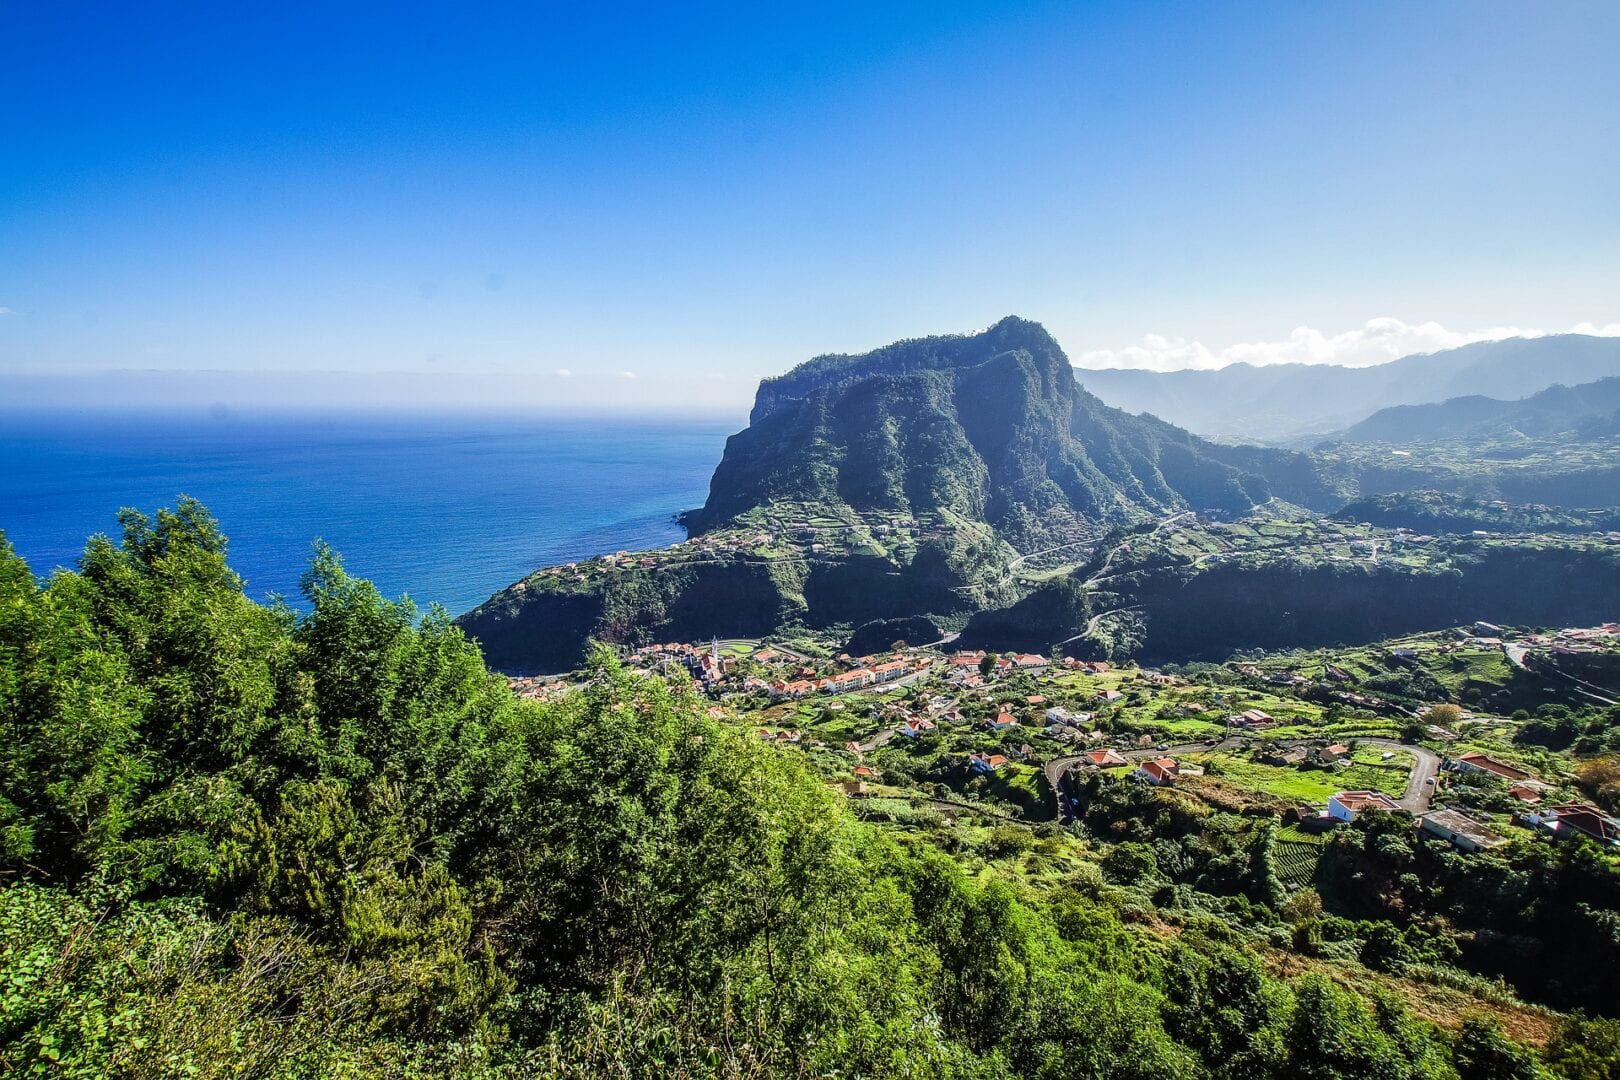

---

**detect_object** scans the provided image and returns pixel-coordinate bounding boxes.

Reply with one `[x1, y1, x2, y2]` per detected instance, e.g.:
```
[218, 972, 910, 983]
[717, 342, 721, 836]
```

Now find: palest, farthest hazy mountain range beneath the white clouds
[1076, 334, 1620, 447]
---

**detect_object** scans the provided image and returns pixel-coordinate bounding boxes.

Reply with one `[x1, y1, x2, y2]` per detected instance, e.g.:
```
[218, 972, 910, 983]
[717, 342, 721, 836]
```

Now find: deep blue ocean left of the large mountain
[0, 415, 742, 614]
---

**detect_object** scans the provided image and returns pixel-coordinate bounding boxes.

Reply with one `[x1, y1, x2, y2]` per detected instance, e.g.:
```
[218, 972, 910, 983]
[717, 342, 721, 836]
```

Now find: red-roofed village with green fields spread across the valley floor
[514, 623, 1620, 886]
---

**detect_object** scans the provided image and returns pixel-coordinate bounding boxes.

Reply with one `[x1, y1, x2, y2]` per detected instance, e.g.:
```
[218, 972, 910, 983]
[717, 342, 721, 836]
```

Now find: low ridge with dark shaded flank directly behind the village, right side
[961, 520, 1620, 661]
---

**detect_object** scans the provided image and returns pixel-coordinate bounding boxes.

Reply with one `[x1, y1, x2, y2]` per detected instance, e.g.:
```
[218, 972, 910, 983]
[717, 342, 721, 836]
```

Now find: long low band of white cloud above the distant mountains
[1074, 316, 1620, 371]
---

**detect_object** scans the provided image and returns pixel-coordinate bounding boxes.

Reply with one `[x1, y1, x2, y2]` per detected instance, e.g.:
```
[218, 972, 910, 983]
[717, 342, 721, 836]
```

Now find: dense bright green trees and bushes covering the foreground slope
[0, 502, 1615, 1078]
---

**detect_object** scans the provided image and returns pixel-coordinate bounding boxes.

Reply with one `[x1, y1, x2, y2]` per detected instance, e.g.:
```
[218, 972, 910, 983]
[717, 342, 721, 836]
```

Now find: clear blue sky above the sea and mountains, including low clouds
[0, 0, 1620, 408]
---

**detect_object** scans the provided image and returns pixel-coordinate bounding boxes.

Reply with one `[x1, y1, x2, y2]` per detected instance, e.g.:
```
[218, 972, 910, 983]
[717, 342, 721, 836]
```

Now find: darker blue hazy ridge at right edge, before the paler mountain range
[1343, 377, 1620, 444]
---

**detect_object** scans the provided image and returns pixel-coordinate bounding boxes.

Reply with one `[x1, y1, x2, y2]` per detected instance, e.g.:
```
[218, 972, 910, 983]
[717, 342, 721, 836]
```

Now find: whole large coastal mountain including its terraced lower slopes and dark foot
[458, 317, 1337, 670]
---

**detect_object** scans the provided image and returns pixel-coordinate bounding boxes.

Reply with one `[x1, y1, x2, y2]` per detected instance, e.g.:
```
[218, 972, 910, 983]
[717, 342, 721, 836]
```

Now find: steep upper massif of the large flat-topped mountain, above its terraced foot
[690, 317, 1324, 547]
